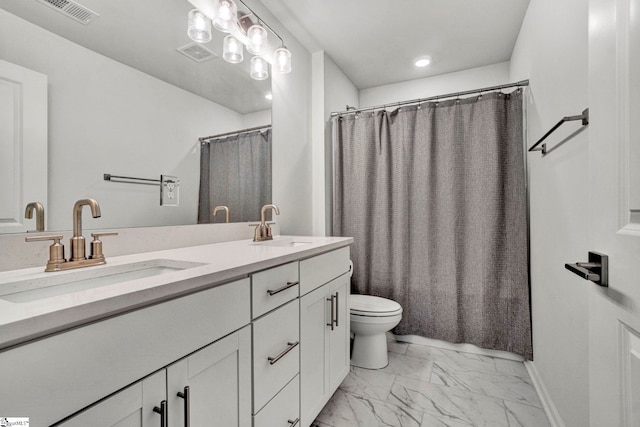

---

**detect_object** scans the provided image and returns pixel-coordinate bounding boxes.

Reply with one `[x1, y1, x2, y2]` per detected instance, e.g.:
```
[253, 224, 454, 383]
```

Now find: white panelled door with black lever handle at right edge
[585, 0, 640, 427]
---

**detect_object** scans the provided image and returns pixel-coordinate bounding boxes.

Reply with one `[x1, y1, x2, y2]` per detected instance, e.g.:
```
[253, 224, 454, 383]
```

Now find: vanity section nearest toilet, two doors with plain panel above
[300, 248, 350, 427]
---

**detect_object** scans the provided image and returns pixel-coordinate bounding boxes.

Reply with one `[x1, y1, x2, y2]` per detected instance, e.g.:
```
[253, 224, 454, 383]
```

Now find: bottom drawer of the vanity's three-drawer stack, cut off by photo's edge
[253, 376, 300, 427]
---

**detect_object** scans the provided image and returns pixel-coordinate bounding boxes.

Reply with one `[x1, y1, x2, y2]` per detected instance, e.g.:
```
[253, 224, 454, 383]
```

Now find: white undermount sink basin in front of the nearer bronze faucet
[0, 259, 204, 303]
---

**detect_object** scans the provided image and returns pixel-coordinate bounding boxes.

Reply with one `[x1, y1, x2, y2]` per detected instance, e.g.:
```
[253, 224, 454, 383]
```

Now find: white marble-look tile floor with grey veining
[312, 341, 550, 427]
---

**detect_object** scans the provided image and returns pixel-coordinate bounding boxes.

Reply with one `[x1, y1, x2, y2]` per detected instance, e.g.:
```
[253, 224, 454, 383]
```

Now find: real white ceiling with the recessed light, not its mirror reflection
[262, 0, 529, 89]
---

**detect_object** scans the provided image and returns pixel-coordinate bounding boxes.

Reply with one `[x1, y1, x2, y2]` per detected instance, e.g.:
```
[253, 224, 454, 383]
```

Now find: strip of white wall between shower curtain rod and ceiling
[360, 62, 510, 110]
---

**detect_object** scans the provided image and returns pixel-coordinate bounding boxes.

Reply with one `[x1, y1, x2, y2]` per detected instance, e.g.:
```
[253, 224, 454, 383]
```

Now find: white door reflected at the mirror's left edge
[0, 60, 48, 233]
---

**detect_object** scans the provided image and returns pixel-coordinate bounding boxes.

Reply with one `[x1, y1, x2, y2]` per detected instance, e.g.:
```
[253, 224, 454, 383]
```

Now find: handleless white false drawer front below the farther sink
[300, 247, 350, 295]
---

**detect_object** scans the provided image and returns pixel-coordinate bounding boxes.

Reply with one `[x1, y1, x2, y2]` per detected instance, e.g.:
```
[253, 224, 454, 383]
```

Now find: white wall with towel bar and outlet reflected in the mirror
[0, 10, 246, 230]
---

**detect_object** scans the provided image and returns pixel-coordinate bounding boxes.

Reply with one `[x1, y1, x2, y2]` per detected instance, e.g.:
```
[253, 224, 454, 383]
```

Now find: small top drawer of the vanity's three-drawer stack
[251, 262, 299, 319]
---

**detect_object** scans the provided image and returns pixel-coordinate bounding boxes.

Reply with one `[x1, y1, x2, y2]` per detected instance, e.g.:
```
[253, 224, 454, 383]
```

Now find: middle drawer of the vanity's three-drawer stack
[253, 299, 300, 414]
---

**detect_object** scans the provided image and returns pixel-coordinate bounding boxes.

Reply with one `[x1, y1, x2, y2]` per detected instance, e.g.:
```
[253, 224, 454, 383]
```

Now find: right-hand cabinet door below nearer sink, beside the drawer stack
[167, 326, 251, 427]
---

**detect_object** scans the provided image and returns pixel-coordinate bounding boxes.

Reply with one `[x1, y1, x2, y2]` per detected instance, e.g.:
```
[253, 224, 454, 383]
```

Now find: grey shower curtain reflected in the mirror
[198, 128, 271, 224]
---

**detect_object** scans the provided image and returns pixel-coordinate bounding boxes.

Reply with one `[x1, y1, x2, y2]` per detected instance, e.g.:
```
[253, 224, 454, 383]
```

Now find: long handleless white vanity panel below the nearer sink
[0, 279, 251, 427]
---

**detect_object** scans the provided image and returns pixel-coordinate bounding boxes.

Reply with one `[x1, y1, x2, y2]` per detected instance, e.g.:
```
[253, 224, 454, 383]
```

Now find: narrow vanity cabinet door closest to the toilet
[327, 274, 351, 395]
